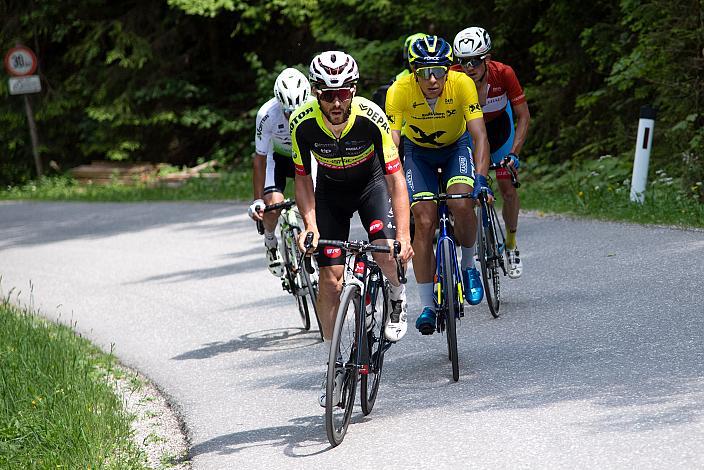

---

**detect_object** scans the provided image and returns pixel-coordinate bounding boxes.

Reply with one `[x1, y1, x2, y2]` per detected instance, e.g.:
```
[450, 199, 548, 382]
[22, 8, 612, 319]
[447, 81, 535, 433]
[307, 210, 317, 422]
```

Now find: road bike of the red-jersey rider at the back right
[477, 157, 520, 318]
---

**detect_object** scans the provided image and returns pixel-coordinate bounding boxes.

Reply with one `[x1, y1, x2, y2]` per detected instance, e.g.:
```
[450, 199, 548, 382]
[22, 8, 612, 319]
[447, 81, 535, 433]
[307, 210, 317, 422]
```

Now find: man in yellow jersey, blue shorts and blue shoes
[386, 36, 493, 334]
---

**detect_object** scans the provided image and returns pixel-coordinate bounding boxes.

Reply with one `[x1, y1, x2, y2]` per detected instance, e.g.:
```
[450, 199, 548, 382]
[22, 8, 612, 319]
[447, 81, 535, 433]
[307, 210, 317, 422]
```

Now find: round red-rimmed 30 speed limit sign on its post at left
[5, 44, 44, 176]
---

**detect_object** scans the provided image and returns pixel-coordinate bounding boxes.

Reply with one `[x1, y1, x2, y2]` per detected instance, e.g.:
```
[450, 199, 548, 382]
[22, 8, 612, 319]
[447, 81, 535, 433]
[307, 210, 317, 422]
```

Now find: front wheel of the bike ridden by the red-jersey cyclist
[477, 205, 502, 318]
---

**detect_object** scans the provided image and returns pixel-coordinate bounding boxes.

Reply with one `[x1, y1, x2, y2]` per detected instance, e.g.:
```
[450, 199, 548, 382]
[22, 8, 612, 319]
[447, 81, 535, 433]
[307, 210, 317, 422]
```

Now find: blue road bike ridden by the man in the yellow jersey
[413, 169, 472, 382]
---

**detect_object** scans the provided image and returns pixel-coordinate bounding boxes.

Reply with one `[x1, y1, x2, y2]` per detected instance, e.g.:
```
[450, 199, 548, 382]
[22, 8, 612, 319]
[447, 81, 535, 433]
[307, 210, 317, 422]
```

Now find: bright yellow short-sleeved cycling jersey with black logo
[386, 70, 483, 148]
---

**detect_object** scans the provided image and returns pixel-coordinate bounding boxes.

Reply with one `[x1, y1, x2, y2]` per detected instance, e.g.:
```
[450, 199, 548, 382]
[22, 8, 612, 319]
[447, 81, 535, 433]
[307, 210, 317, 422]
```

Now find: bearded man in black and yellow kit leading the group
[290, 51, 413, 406]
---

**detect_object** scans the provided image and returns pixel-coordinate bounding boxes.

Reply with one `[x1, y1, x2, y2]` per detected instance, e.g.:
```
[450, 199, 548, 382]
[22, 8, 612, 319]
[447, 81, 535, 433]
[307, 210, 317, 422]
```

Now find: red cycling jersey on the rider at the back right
[450, 60, 526, 122]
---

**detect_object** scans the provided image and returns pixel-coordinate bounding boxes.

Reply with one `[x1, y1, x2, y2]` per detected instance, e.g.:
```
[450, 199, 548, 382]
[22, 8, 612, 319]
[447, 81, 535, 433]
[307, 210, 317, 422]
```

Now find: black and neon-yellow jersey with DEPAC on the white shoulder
[289, 96, 401, 190]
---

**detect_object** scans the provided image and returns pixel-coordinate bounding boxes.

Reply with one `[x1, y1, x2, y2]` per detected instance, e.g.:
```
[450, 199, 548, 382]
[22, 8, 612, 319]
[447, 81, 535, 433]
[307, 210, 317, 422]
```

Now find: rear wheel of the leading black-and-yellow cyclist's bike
[359, 273, 389, 416]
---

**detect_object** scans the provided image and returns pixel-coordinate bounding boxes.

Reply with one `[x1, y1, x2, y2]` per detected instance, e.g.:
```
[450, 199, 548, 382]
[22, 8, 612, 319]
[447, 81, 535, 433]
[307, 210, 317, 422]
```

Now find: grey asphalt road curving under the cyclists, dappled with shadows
[0, 202, 704, 469]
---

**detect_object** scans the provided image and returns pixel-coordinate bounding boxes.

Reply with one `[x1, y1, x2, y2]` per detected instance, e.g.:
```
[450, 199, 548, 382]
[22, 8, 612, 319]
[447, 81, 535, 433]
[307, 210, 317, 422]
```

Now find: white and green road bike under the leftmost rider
[257, 199, 323, 340]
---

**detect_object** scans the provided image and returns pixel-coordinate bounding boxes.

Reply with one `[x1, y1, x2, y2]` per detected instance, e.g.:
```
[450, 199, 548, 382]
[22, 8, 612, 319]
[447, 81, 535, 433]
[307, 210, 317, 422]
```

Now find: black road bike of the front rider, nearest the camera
[310, 240, 406, 447]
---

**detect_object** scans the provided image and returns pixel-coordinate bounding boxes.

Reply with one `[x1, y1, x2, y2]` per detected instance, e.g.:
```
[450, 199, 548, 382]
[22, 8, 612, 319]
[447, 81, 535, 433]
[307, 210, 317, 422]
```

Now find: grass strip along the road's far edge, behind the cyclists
[0, 155, 704, 227]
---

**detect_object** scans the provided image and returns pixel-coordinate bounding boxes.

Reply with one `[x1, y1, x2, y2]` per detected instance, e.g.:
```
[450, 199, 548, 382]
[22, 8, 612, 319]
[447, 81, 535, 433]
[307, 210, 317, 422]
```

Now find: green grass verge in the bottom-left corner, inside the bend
[0, 298, 146, 469]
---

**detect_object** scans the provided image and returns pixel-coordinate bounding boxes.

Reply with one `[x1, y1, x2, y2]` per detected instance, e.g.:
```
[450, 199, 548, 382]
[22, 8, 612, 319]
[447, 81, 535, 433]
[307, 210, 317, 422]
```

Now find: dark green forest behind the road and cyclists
[0, 0, 704, 206]
